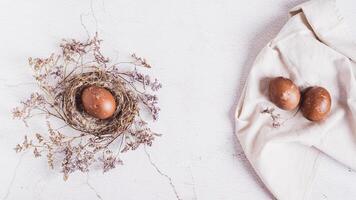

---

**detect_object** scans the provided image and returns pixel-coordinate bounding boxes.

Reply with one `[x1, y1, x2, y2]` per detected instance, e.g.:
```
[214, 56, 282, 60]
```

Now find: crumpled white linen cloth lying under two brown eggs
[236, 0, 356, 200]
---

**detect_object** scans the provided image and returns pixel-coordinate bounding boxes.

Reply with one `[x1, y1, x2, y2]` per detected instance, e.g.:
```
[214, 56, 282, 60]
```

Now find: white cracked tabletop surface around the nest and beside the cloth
[0, 0, 356, 200]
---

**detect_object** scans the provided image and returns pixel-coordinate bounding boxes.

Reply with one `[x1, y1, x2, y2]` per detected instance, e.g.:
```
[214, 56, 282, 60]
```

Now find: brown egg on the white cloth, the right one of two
[301, 87, 331, 121]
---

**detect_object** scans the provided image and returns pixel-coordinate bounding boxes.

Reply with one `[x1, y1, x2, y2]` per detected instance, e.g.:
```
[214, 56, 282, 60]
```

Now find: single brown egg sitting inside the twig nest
[81, 86, 116, 119]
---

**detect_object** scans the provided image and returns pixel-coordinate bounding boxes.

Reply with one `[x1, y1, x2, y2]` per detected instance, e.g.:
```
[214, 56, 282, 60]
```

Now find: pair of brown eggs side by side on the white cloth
[268, 77, 331, 121]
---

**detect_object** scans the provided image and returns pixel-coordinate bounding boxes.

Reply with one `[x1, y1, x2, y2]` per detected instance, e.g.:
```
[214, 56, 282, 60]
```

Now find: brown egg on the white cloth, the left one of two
[268, 77, 300, 110]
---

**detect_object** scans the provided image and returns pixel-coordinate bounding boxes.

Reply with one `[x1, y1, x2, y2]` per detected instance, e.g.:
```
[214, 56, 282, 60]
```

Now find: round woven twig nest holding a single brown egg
[62, 71, 138, 135]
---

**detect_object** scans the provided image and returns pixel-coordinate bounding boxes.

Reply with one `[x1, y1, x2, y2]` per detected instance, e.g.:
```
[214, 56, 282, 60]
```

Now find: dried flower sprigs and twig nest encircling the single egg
[12, 34, 162, 180]
